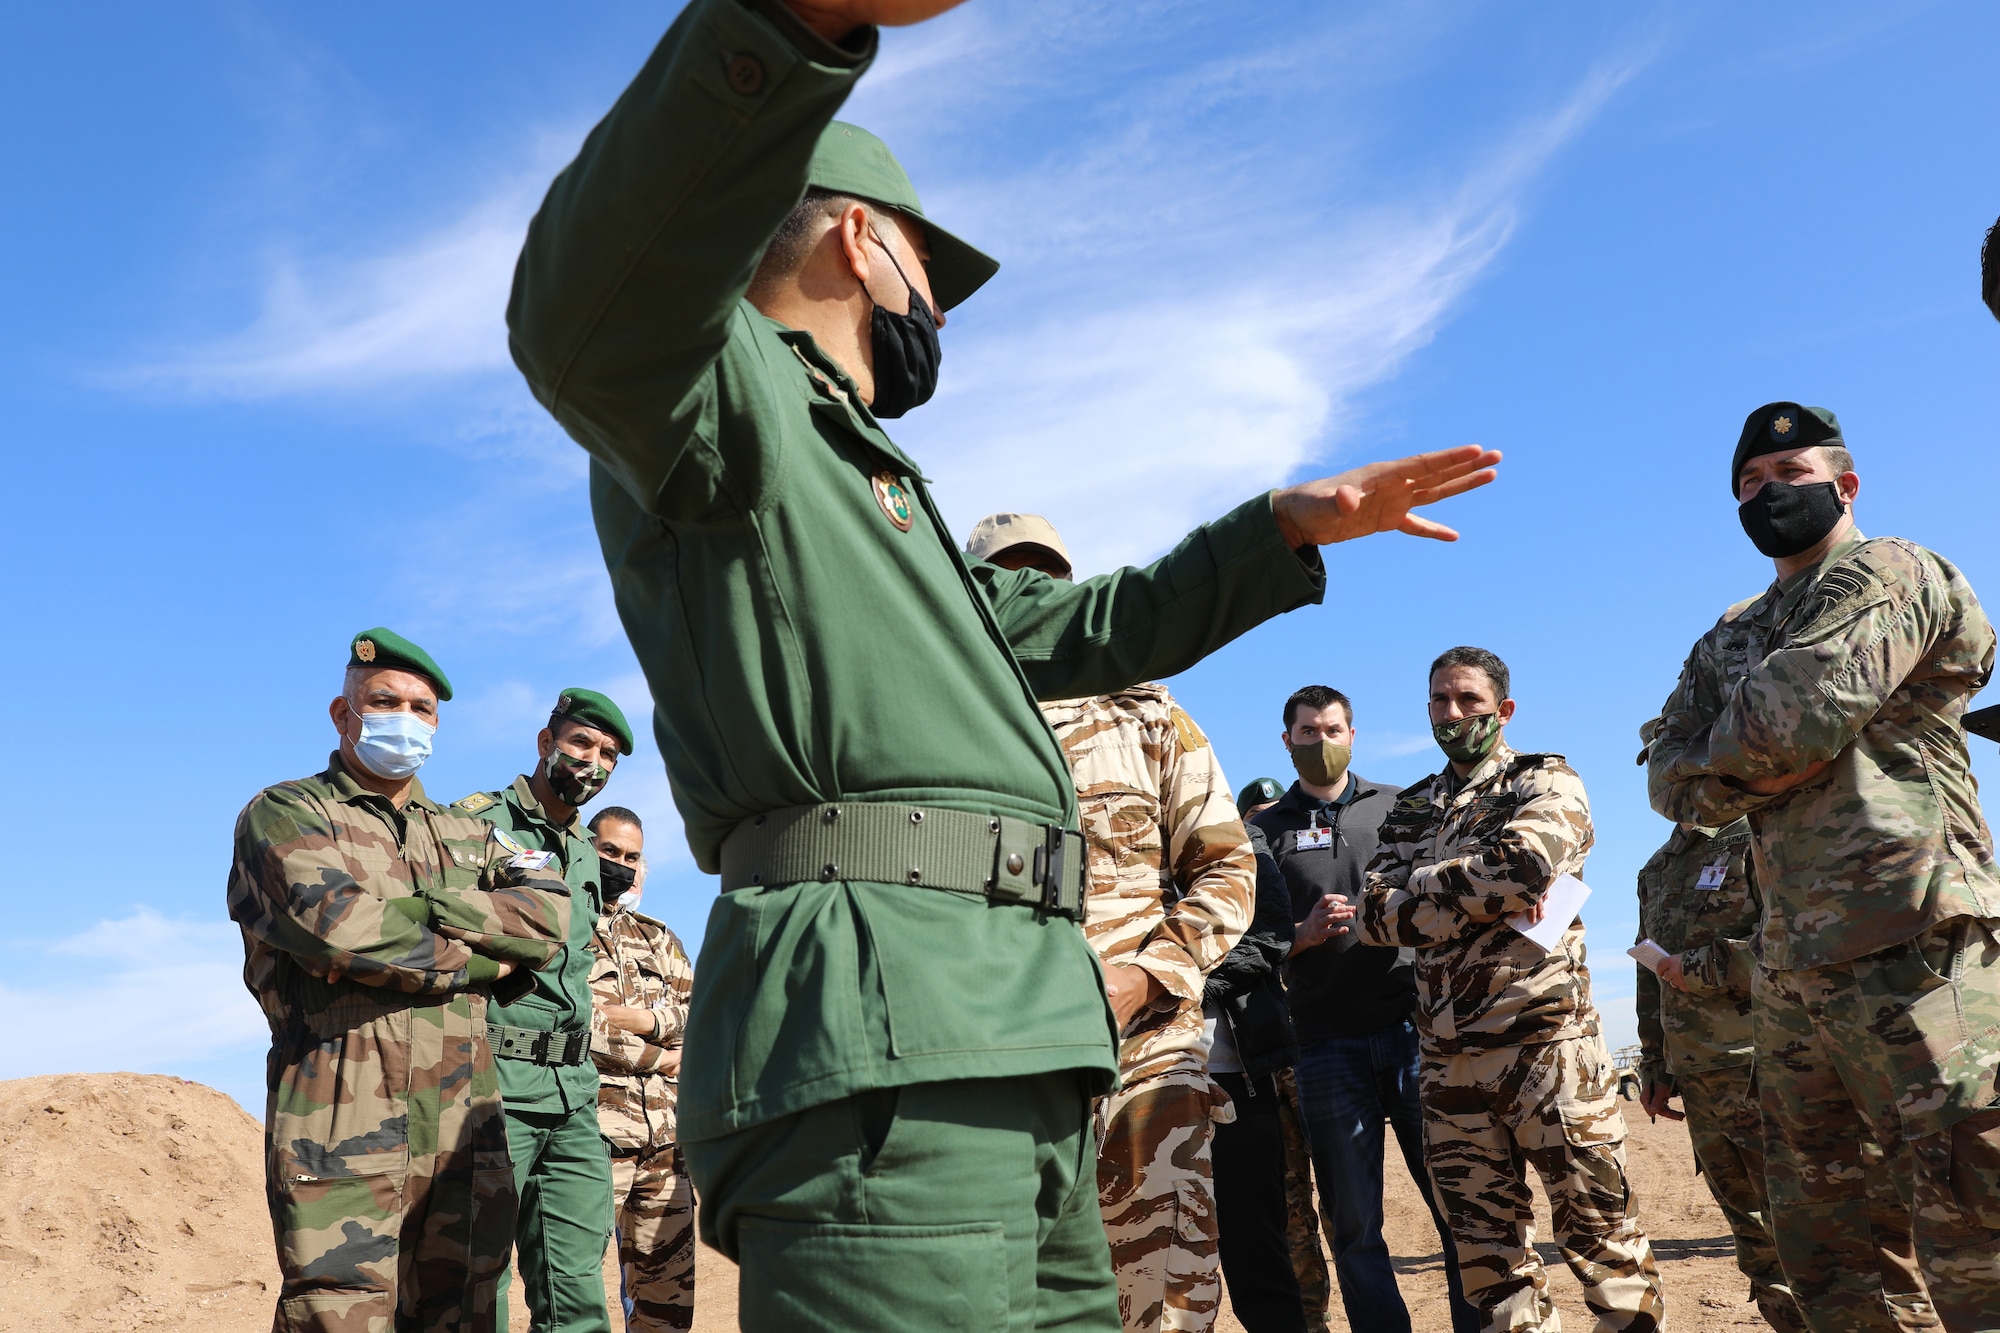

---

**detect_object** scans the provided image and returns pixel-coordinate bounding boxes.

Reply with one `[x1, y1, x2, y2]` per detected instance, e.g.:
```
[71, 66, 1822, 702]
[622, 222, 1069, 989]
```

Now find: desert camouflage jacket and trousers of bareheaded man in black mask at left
[590, 907, 694, 1333]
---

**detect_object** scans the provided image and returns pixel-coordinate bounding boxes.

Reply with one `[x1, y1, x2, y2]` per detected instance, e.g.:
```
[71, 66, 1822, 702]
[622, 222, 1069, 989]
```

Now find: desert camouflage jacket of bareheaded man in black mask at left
[590, 907, 694, 1157]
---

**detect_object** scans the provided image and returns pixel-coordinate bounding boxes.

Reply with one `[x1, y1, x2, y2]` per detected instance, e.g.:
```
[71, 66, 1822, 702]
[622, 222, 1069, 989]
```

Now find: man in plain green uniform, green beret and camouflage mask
[452, 689, 632, 1333]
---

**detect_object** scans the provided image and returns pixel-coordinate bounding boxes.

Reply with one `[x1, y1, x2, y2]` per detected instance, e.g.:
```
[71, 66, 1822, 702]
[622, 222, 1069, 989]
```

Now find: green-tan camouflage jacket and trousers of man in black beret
[1650, 532, 2000, 1329]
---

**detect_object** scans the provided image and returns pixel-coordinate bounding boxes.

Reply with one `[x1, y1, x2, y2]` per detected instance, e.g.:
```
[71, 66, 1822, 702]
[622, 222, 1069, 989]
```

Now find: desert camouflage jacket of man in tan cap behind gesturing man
[1042, 685, 1256, 1083]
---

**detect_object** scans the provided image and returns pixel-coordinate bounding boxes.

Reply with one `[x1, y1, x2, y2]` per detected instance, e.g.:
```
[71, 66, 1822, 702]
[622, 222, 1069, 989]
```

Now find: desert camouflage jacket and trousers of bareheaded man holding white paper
[1356, 745, 1664, 1333]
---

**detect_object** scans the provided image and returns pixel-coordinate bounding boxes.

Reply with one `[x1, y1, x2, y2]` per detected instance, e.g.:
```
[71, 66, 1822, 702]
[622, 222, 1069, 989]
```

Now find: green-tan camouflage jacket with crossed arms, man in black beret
[1648, 532, 2000, 969]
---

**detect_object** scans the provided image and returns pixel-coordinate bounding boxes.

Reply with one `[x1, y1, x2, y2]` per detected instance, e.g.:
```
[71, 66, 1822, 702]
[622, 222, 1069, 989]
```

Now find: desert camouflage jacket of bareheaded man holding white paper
[1356, 745, 1598, 1055]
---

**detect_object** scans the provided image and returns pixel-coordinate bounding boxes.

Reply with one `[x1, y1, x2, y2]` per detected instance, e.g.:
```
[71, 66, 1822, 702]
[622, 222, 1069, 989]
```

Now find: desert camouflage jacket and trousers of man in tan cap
[1042, 685, 1256, 1333]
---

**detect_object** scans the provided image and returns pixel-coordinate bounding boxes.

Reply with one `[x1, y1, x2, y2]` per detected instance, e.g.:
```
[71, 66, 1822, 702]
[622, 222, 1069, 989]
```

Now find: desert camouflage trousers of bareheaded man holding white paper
[1420, 1037, 1666, 1333]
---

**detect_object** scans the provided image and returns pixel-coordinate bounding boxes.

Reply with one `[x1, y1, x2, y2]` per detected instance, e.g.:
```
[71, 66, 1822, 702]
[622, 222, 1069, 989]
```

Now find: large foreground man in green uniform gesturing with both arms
[508, 0, 1498, 1333]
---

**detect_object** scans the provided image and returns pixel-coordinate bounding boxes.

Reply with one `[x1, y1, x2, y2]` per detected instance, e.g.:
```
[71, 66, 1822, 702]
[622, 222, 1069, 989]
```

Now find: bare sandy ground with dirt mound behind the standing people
[0, 1075, 1760, 1333]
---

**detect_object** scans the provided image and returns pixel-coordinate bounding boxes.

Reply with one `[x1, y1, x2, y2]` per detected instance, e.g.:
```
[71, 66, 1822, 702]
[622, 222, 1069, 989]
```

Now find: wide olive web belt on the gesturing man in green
[722, 803, 1086, 921]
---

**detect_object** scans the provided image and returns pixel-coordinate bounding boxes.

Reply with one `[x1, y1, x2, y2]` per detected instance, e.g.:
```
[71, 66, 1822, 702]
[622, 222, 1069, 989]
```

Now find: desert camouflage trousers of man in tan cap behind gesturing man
[1098, 1071, 1236, 1333]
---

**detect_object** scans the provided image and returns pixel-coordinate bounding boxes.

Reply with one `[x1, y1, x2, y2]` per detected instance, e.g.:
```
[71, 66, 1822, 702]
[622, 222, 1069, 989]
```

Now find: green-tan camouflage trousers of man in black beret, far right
[1752, 917, 2000, 1333]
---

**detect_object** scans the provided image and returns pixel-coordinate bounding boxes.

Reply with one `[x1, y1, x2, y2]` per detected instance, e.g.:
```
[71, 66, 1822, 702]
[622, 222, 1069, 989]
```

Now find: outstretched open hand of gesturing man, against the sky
[1272, 444, 1500, 546]
